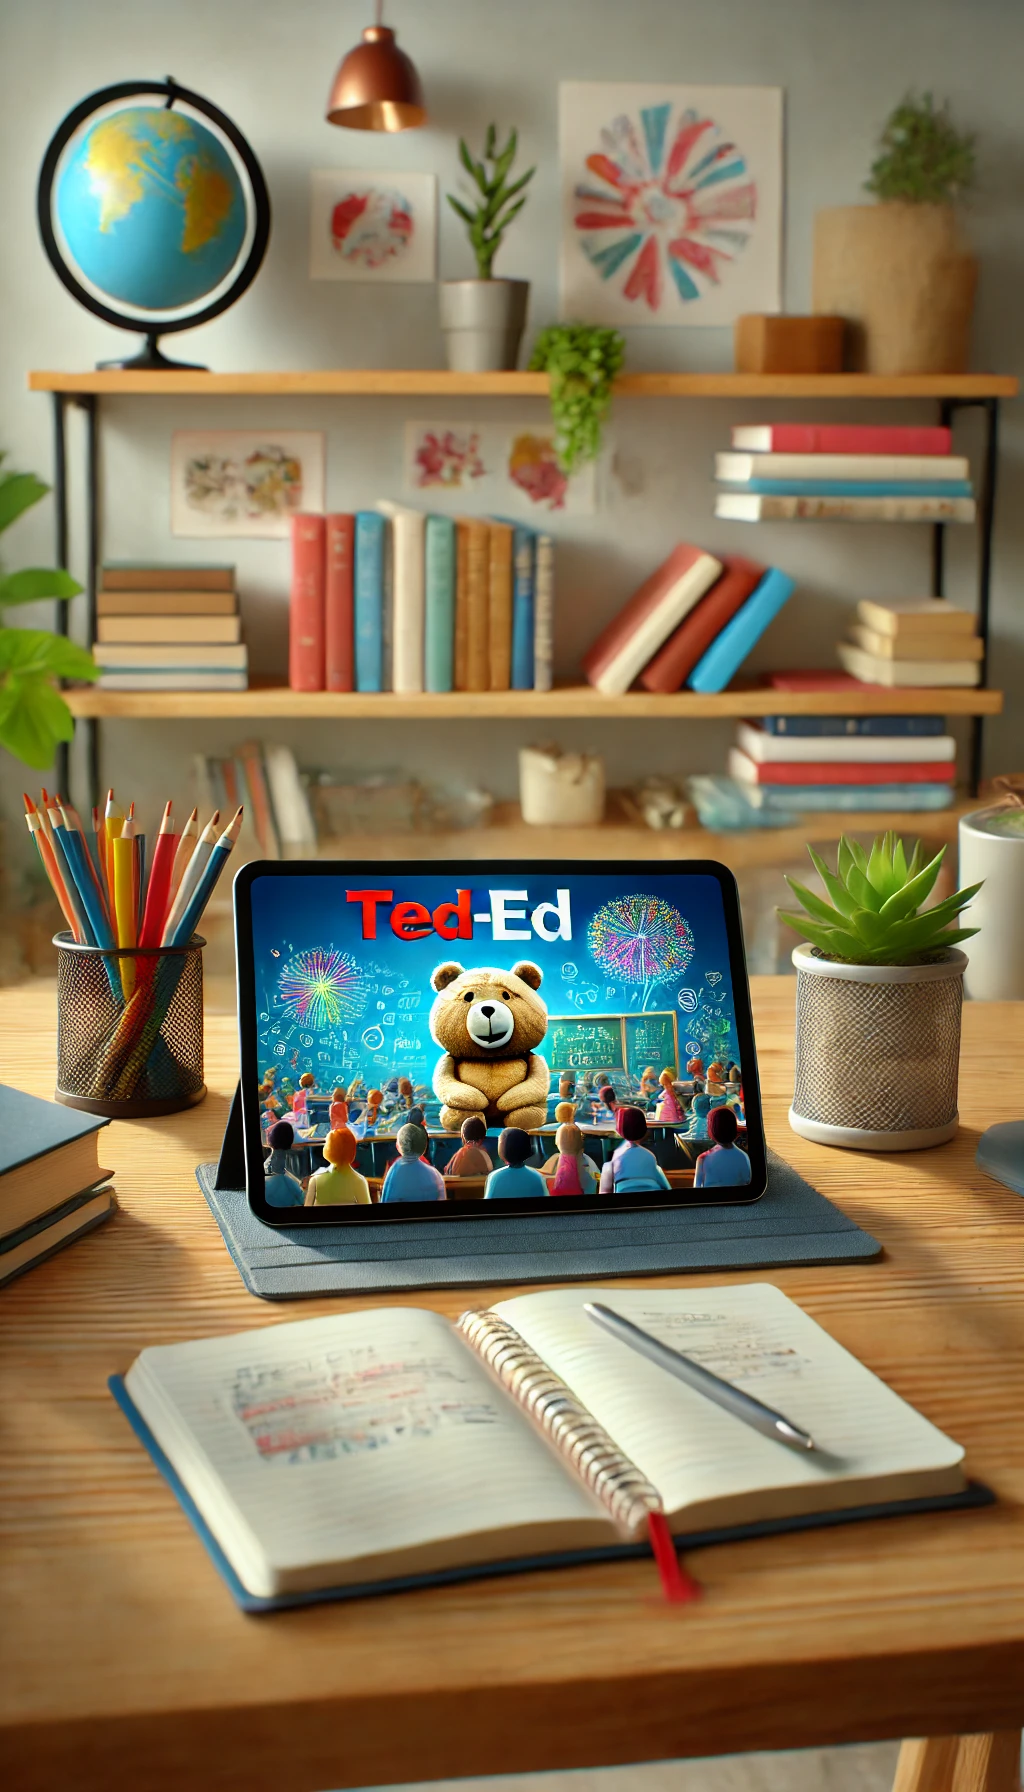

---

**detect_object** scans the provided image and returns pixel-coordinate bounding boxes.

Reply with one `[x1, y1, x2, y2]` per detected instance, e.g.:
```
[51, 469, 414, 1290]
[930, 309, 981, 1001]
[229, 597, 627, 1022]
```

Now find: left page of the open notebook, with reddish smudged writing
[127, 1308, 615, 1593]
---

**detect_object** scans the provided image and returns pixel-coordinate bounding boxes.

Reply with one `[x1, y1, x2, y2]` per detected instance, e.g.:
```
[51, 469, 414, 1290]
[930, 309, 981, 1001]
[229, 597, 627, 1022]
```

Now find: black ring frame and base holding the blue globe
[36, 75, 271, 373]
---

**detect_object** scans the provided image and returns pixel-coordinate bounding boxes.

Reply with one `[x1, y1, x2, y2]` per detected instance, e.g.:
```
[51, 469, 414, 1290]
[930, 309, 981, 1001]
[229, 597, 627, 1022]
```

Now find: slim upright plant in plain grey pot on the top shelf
[441, 124, 536, 373]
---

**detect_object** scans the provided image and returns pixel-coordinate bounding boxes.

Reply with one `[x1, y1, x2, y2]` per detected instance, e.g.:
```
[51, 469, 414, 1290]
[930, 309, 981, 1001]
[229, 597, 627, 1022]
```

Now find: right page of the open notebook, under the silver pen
[493, 1283, 963, 1521]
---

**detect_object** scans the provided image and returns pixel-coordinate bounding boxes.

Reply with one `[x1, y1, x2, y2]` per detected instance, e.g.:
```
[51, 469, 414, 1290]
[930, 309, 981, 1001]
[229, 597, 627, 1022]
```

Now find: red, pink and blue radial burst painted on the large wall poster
[572, 100, 759, 314]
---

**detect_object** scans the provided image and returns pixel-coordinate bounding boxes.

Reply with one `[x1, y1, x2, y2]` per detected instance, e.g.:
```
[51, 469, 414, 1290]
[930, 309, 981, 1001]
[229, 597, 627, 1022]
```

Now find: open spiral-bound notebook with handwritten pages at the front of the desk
[115, 1283, 974, 1609]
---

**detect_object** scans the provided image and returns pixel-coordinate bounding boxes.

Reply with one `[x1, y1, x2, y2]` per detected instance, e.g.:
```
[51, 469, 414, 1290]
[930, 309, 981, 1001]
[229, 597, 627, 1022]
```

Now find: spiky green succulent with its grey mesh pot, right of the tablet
[778, 833, 981, 1150]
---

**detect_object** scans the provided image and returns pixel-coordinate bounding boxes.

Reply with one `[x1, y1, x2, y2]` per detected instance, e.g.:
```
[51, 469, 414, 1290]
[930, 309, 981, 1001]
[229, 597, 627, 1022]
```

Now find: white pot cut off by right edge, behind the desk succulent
[958, 808, 1024, 1002]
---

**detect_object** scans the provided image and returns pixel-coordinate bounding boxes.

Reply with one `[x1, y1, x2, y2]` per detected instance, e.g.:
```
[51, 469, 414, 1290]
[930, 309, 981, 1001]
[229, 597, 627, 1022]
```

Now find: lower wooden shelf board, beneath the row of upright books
[65, 679, 1002, 722]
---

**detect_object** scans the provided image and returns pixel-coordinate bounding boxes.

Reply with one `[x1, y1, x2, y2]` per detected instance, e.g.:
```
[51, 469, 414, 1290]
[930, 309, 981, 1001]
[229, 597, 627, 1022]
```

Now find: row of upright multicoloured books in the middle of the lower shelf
[289, 504, 554, 694]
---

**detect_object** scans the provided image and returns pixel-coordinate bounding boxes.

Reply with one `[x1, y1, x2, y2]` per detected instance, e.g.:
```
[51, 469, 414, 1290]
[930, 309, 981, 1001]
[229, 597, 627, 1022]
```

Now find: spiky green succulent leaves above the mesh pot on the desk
[778, 833, 981, 964]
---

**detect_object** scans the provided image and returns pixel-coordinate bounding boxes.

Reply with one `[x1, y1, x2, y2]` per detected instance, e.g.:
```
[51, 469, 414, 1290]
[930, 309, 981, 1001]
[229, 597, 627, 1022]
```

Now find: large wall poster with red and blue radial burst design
[560, 81, 782, 326]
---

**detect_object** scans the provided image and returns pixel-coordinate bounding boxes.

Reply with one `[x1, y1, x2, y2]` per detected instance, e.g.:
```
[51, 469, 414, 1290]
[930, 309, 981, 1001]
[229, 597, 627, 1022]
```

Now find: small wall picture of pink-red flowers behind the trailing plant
[404, 421, 597, 527]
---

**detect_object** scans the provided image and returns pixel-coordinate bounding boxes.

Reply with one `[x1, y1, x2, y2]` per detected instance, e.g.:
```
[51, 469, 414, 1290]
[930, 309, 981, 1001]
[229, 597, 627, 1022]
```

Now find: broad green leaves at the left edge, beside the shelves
[0, 455, 99, 771]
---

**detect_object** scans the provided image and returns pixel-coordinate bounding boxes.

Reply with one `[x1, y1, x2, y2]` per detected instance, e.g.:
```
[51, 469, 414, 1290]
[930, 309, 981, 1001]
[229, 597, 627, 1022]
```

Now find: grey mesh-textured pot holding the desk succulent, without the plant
[789, 946, 967, 1150]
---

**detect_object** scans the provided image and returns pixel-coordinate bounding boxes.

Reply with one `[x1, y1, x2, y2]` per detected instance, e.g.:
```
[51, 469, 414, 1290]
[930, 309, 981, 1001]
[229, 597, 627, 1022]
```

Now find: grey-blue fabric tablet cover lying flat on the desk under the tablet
[195, 1150, 882, 1301]
